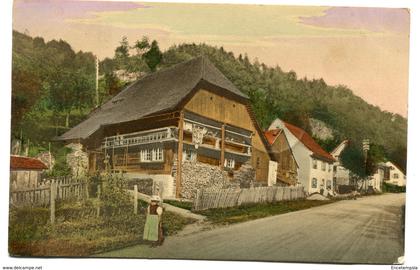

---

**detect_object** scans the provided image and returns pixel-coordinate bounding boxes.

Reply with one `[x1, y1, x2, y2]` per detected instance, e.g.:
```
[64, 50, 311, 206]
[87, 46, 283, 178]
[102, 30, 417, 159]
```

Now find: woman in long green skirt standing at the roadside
[143, 196, 163, 245]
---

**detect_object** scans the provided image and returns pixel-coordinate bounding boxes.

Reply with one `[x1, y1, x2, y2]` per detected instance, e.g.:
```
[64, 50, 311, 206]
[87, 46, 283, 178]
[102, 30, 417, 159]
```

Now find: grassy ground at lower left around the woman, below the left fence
[9, 199, 194, 257]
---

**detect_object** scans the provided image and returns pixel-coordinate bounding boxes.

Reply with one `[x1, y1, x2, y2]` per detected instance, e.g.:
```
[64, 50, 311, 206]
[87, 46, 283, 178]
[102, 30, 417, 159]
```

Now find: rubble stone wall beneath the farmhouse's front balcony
[181, 161, 232, 199]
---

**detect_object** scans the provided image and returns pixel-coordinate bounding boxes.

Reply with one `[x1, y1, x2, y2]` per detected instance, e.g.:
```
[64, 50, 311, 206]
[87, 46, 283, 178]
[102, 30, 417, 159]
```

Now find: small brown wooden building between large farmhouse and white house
[265, 129, 298, 186]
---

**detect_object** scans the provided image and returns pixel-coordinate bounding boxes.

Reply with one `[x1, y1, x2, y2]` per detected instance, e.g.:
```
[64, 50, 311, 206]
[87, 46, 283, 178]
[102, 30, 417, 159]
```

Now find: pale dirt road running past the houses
[100, 194, 405, 264]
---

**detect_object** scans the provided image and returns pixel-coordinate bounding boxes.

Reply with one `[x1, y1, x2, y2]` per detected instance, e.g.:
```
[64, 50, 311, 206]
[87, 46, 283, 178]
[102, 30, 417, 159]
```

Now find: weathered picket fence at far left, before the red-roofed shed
[10, 178, 88, 207]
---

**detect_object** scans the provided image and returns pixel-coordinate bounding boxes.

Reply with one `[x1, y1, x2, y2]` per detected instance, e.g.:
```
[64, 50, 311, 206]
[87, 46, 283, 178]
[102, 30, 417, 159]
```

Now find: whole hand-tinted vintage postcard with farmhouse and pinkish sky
[7, 0, 411, 265]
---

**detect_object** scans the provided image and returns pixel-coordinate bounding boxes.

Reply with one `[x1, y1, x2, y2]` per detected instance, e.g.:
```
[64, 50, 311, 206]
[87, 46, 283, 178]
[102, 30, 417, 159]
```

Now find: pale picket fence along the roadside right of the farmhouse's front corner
[193, 186, 305, 210]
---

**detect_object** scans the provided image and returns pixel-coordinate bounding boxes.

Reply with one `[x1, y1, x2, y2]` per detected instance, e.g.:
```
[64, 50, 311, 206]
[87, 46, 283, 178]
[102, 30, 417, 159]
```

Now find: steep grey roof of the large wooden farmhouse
[58, 56, 248, 140]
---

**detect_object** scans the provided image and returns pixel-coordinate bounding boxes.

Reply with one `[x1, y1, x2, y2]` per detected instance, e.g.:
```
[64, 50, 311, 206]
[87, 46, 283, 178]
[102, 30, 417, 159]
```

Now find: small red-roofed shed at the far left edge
[10, 156, 48, 189]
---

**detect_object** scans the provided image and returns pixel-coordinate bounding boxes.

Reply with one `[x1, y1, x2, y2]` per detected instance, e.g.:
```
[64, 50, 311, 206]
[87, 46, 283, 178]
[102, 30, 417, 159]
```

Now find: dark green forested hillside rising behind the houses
[12, 32, 407, 172]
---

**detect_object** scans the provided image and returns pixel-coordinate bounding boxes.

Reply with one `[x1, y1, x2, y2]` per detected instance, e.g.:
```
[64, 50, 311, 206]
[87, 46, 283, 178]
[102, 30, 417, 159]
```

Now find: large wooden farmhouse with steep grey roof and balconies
[59, 57, 270, 198]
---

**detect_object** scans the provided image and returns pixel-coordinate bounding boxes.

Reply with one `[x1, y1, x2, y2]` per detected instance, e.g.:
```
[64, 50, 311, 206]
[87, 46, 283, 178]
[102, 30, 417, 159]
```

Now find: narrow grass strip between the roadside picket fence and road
[197, 200, 334, 224]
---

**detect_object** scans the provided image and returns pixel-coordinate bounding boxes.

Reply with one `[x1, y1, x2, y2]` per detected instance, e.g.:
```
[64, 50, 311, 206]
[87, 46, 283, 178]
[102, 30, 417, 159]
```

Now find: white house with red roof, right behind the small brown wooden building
[269, 119, 336, 194]
